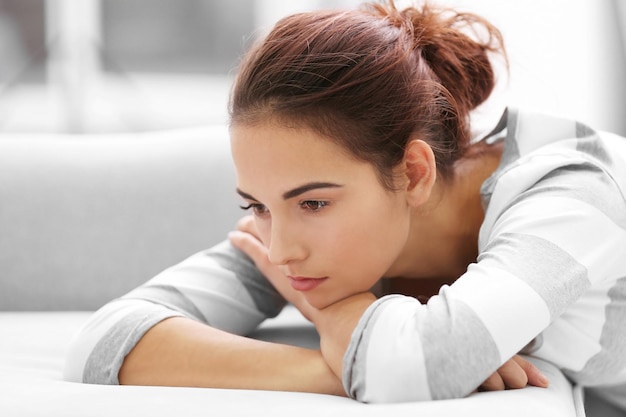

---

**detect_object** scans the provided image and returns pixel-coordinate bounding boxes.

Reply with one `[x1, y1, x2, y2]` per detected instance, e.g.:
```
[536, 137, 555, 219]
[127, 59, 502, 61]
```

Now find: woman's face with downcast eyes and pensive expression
[231, 123, 410, 308]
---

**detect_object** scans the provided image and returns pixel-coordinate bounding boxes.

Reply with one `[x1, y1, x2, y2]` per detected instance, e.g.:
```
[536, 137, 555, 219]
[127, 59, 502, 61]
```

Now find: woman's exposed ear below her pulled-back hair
[403, 139, 437, 207]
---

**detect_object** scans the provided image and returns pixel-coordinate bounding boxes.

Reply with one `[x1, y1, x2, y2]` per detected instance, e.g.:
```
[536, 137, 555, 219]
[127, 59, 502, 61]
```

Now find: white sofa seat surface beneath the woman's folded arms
[0, 307, 584, 417]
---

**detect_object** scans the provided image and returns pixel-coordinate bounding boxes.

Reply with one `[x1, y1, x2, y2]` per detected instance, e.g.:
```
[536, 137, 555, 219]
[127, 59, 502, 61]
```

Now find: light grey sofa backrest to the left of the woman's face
[0, 126, 242, 310]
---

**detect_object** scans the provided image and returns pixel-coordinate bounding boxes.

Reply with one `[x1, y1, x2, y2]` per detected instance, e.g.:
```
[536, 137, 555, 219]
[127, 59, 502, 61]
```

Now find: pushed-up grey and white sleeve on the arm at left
[64, 241, 286, 384]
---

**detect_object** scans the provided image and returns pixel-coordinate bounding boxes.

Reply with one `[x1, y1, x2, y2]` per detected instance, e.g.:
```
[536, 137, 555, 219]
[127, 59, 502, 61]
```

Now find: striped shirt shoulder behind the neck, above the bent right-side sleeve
[481, 109, 626, 207]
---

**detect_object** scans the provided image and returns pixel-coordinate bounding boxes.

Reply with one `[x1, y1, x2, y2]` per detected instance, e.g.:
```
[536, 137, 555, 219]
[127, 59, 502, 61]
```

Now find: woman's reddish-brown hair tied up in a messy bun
[230, 0, 504, 189]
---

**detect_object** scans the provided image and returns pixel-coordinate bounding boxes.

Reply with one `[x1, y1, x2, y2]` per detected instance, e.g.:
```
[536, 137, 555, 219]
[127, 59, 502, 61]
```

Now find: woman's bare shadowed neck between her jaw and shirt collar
[388, 144, 502, 282]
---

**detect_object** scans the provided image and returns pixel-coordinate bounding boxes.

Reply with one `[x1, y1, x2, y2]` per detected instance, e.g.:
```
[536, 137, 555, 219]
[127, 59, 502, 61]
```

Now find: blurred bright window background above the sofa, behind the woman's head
[0, 0, 626, 134]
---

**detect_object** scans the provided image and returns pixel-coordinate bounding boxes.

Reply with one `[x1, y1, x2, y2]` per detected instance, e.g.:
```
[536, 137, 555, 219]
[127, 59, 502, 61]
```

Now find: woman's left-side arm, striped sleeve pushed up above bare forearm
[64, 242, 343, 393]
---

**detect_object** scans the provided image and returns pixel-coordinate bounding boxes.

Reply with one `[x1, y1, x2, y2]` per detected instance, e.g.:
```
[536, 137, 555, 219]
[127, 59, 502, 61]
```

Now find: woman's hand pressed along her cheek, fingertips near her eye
[228, 216, 318, 322]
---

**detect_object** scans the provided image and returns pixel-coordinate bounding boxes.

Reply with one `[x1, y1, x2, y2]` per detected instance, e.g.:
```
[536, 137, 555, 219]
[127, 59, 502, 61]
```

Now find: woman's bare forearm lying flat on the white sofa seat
[119, 317, 345, 395]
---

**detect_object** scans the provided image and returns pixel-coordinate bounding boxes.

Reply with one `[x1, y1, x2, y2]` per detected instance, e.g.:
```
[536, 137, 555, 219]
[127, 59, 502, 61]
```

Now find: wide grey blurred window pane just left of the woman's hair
[101, 0, 255, 74]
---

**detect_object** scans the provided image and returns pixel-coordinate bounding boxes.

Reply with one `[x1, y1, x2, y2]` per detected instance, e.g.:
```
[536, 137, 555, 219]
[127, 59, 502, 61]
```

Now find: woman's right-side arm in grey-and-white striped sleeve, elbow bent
[342, 161, 626, 402]
